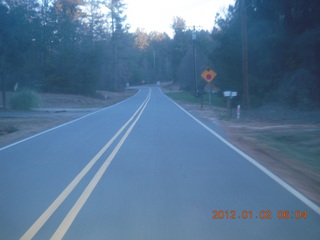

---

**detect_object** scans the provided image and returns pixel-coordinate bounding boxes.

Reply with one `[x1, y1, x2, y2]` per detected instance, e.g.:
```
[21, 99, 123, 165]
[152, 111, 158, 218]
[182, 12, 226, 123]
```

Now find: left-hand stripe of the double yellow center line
[20, 89, 150, 240]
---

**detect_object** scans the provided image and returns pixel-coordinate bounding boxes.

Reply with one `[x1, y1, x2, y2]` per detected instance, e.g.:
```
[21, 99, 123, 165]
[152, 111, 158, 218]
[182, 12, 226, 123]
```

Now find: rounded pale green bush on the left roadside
[10, 89, 40, 110]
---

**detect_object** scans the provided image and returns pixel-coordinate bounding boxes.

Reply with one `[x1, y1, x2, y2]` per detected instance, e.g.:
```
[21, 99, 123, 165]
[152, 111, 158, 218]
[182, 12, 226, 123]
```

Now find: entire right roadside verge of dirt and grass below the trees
[165, 91, 320, 205]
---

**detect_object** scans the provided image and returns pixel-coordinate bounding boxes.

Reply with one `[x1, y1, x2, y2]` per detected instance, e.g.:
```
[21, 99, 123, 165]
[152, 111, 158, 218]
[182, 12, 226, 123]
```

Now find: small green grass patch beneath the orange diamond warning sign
[166, 92, 226, 107]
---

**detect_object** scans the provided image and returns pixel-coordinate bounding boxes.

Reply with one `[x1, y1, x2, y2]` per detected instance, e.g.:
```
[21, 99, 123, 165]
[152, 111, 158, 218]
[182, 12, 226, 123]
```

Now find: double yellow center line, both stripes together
[20, 89, 151, 240]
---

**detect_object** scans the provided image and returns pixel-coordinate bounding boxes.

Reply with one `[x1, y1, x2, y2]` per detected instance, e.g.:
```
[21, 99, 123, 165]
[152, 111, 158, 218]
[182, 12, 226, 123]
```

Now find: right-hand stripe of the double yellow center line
[51, 91, 150, 240]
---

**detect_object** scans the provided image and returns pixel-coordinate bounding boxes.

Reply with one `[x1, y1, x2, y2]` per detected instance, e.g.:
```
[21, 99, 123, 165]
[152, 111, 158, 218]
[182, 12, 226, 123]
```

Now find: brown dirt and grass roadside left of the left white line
[0, 90, 137, 148]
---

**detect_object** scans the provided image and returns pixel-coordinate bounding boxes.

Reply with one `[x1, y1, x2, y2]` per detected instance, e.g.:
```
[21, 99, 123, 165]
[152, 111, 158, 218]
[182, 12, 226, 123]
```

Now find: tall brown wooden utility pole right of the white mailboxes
[240, 0, 249, 109]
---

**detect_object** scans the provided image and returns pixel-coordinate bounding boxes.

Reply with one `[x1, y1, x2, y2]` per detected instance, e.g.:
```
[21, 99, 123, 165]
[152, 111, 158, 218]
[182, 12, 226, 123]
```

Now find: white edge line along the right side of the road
[160, 90, 320, 215]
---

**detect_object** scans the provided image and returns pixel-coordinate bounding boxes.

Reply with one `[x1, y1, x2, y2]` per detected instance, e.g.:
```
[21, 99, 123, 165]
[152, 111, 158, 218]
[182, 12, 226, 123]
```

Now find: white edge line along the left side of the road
[0, 89, 140, 151]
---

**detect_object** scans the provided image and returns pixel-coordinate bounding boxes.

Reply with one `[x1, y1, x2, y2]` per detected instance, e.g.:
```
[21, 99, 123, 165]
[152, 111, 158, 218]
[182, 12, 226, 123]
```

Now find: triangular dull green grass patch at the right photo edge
[255, 128, 320, 172]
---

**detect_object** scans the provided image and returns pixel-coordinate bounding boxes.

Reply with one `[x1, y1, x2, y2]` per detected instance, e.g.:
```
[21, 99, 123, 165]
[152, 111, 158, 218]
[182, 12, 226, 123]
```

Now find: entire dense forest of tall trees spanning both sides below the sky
[0, 0, 320, 108]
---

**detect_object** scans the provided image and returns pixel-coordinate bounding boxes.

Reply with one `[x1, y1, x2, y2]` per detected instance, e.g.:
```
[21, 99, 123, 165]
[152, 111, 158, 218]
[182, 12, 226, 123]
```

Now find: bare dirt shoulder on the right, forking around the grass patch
[164, 91, 320, 206]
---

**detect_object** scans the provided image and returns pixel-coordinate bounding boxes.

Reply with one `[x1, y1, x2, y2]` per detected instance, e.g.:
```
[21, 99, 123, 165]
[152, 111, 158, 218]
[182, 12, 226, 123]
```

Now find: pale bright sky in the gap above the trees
[124, 0, 235, 37]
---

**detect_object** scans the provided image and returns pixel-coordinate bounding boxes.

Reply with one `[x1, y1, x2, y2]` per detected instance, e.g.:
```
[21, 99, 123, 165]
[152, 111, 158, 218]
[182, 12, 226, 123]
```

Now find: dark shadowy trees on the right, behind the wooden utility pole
[211, 0, 320, 108]
